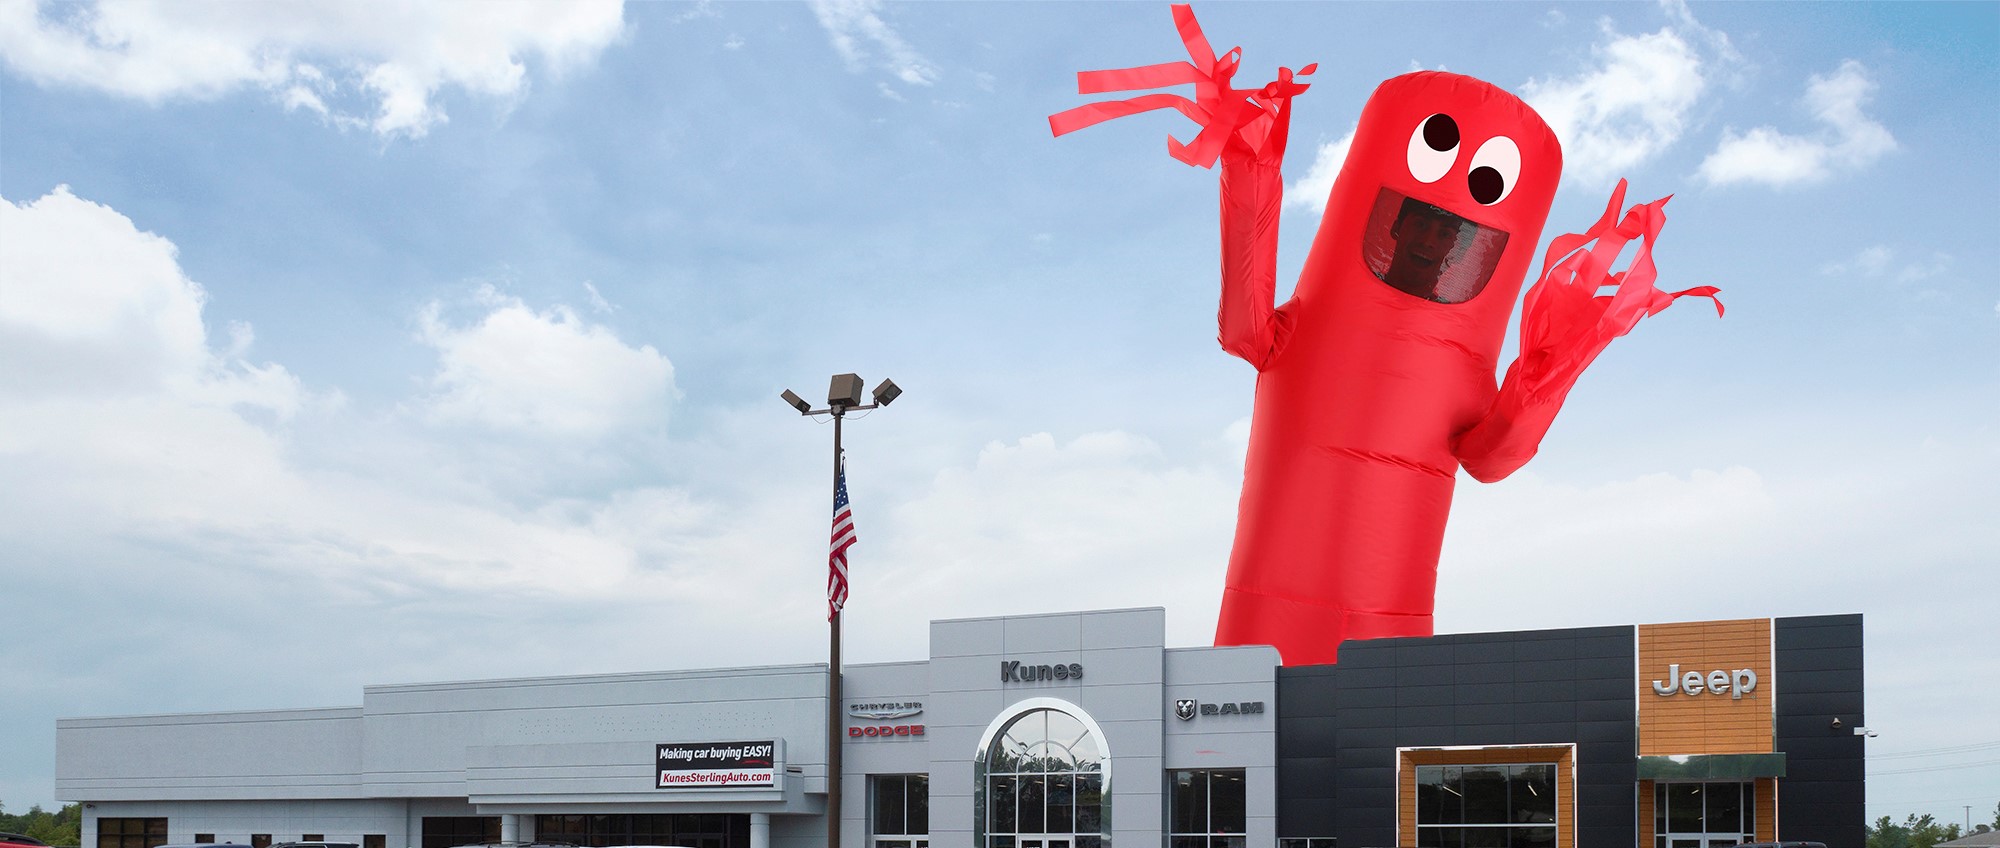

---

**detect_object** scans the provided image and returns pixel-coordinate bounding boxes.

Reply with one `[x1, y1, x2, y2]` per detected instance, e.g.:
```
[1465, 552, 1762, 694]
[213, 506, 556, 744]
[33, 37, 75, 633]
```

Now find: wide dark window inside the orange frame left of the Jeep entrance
[1416, 762, 1556, 848]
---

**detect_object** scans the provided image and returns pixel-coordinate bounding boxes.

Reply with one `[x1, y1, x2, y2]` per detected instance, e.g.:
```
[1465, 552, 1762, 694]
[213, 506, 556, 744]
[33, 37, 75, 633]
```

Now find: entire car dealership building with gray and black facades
[56, 608, 1866, 848]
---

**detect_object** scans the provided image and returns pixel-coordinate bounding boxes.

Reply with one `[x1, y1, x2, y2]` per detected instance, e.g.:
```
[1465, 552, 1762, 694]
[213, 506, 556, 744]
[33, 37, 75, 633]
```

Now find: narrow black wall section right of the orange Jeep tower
[1772, 614, 1868, 846]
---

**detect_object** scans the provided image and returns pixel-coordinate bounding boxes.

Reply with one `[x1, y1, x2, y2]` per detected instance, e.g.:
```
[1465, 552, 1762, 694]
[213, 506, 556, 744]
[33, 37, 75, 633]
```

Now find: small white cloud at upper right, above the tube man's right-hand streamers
[1700, 60, 1896, 188]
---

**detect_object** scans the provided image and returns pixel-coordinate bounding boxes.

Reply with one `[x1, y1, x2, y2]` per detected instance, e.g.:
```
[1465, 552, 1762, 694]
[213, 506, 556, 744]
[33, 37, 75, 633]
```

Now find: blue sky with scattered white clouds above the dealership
[0, 0, 2000, 820]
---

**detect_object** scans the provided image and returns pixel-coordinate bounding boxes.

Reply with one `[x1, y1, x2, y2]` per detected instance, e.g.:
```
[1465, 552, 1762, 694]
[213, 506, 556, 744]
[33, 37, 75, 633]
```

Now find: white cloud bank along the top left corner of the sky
[0, 0, 624, 138]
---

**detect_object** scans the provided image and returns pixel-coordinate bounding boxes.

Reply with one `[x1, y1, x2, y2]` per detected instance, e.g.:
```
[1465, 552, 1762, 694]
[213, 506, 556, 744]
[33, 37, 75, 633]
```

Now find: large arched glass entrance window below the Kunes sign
[972, 698, 1110, 848]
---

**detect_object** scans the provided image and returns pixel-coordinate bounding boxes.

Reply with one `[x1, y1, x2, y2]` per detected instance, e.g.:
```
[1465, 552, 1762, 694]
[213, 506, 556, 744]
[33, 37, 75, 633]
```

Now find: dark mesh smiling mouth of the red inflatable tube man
[1362, 188, 1506, 304]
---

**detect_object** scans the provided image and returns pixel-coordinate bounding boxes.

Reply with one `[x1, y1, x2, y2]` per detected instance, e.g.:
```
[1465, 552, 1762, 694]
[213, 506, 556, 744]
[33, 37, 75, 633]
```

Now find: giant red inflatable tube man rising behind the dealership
[1050, 6, 1720, 664]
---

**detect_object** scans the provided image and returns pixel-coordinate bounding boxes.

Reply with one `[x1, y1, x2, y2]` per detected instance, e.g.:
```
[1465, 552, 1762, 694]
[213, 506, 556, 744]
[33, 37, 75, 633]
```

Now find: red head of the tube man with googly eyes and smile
[1322, 72, 1562, 310]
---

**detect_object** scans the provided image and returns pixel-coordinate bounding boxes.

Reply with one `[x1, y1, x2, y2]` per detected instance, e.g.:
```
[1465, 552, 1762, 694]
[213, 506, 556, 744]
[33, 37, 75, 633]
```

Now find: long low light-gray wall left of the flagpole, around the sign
[56, 666, 826, 820]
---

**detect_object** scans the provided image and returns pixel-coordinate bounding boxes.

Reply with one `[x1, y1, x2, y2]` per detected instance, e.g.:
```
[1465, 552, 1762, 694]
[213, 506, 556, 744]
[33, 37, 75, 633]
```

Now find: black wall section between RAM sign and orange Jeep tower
[1278, 626, 1638, 846]
